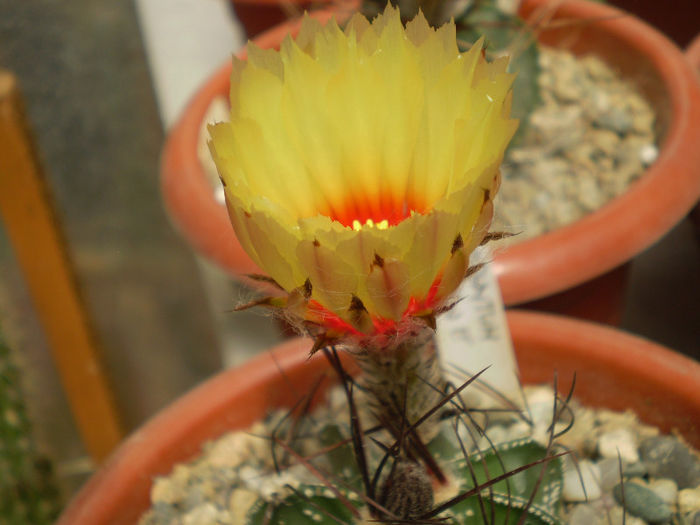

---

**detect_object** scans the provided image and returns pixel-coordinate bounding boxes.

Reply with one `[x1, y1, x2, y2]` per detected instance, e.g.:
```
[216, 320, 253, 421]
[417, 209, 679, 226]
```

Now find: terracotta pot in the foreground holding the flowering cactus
[58, 311, 700, 525]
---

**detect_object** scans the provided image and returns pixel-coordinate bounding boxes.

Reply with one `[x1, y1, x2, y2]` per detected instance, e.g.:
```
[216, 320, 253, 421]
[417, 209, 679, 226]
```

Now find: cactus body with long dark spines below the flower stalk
[227, 344, 568, 525]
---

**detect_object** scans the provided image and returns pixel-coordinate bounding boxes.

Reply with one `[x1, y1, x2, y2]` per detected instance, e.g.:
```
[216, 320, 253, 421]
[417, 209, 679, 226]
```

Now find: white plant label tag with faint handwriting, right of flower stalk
[437, 246, 520, 402]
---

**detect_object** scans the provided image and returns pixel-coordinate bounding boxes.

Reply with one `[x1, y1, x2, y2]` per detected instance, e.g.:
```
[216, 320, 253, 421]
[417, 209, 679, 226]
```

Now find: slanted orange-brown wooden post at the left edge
[0, 70, 123, 462]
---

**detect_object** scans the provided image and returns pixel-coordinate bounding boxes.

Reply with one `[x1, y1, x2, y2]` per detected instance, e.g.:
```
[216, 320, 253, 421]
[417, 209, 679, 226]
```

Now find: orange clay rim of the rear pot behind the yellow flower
[161, 0, 700, 305]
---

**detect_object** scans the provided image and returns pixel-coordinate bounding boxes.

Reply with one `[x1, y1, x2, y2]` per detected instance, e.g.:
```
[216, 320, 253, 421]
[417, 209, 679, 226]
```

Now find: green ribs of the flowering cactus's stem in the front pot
[245, 422, 562, 525]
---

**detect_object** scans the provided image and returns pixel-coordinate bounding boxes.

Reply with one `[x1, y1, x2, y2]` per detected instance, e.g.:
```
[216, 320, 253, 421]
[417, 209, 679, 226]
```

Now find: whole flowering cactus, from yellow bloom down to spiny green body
[202, 6, 561, 525]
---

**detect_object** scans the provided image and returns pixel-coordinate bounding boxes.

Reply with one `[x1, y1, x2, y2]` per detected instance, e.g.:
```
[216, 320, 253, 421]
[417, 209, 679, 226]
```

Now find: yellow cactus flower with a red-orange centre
[210, 6, 517, 348]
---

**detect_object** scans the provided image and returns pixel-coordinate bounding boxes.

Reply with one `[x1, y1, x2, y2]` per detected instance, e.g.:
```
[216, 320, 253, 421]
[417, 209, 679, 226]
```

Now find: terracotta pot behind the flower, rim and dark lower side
[161, 0, 700, 321]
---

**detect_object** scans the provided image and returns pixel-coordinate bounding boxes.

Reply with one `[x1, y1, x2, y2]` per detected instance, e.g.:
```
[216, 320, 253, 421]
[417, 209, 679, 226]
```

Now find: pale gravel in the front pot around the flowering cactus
[140, 387, 700, 525]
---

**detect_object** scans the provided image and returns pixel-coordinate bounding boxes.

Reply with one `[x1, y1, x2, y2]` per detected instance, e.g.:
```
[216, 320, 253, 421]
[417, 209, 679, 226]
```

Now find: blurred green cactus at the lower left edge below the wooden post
[0, 326, 59, 525]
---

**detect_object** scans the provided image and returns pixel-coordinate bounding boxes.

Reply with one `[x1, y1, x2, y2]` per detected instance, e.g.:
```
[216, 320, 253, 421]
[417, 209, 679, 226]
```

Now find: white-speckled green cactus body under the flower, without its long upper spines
[245, 378, 562, 525]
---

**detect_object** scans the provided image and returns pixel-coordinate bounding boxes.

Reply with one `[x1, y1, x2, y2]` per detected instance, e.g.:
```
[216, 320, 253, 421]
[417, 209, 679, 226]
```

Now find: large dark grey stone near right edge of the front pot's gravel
[639, 436, 700, 489]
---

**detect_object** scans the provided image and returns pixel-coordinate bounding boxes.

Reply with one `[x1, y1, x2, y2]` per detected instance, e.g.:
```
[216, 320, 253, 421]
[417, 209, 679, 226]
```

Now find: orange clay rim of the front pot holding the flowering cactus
[57, 311, 700, 525]
